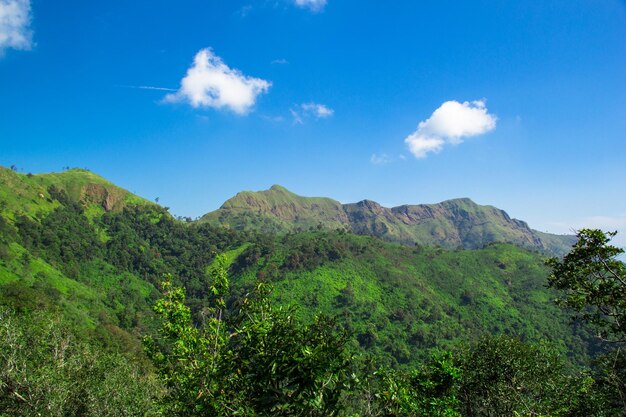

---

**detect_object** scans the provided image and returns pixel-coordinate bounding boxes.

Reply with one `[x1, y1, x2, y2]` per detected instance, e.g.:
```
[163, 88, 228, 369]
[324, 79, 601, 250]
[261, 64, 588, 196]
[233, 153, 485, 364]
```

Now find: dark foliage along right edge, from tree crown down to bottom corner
[548, 229, 626, 415]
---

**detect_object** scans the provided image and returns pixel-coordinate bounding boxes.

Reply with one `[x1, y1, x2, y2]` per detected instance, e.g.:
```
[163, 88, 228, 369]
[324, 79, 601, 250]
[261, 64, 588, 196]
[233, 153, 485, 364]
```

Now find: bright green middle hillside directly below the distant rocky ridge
[231, 232, 588, 368]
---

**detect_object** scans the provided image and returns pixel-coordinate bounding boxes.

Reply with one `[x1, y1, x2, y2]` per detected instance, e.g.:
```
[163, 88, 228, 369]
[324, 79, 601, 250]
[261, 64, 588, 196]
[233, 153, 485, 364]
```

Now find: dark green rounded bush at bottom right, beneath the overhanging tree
[458, 337, 604, 417]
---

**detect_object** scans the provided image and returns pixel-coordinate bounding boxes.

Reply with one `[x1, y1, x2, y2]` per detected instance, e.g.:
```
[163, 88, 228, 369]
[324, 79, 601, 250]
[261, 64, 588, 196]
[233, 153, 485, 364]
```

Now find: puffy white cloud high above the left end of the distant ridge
[164, 48, 272, 114]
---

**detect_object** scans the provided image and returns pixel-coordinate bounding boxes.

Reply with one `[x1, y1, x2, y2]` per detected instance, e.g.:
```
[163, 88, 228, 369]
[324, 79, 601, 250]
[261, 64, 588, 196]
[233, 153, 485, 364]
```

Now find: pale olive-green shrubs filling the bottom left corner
[0, 307, 160, 417]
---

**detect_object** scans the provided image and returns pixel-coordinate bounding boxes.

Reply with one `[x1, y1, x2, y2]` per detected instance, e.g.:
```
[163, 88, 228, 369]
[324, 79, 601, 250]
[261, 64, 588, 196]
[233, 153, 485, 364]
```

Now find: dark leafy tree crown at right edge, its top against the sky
[547, 229, 626, 342]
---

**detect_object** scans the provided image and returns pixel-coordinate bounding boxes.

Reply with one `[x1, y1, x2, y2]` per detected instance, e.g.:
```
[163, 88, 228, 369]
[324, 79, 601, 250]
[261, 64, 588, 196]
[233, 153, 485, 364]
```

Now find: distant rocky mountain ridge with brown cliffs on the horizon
[199, 185, 575, 255]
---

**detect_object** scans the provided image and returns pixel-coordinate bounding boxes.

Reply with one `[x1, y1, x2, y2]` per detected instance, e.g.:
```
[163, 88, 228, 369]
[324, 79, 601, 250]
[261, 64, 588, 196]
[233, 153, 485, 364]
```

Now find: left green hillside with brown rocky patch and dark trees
[0, 167, 242, 338]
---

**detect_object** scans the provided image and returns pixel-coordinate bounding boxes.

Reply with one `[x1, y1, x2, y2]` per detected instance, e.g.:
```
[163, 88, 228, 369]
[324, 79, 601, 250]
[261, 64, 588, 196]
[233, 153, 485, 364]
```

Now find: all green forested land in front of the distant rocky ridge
[0, 168, 626, 416]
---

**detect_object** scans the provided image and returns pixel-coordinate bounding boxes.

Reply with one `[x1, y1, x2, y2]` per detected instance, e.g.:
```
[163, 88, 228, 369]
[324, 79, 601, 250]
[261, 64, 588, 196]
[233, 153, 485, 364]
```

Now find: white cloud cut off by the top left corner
[0, 0, 33, 55]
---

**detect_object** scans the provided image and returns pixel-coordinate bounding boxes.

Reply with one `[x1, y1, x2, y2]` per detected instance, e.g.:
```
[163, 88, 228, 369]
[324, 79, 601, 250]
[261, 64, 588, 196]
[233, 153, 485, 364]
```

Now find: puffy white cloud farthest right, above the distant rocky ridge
[404, 100, 497, 158]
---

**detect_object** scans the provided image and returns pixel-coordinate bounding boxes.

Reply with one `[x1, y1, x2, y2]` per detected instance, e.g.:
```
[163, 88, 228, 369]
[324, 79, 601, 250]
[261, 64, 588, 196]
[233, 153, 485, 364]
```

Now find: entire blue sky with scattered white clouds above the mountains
[0, 0, 626, 242]
